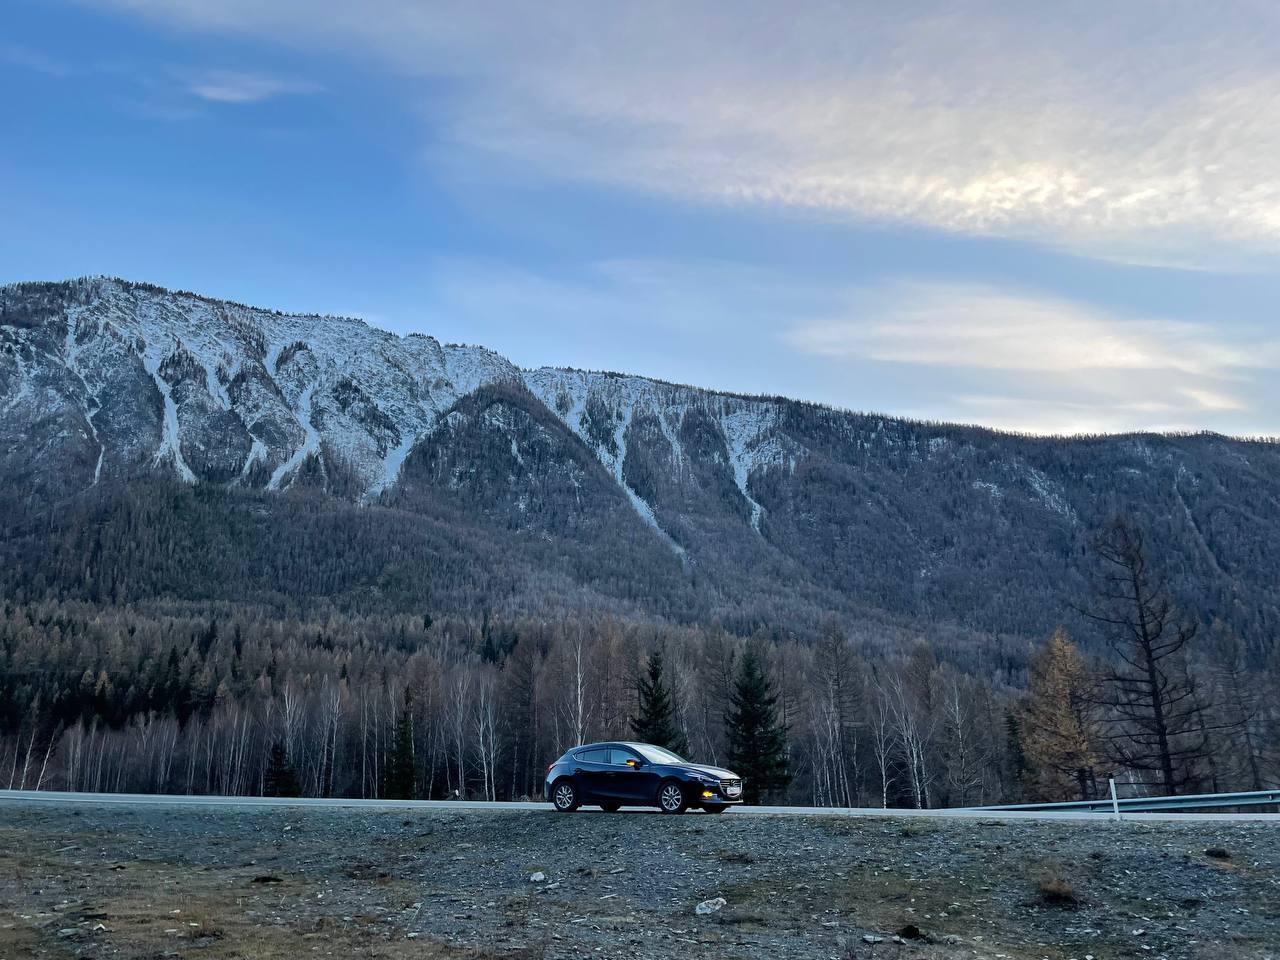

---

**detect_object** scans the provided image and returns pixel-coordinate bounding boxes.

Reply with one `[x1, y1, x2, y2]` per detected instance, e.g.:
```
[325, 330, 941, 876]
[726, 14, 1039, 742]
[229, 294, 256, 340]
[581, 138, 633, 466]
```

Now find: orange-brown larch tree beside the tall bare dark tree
[1023, 630, 1098, 800]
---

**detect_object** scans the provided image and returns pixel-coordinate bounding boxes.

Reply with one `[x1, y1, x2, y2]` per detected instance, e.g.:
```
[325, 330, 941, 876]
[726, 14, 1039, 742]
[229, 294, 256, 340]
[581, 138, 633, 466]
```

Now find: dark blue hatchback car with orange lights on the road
[547, 741, 742, 814]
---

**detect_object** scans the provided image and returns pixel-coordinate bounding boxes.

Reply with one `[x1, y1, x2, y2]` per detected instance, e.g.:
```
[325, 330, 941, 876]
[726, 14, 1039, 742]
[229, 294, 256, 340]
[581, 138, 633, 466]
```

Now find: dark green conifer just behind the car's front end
[724, 648, 791, 804]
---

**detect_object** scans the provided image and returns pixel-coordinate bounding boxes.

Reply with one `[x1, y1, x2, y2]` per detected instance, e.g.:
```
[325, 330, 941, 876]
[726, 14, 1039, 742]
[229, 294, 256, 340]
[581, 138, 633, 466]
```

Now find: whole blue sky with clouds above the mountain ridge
[0, 0, 1280, 435]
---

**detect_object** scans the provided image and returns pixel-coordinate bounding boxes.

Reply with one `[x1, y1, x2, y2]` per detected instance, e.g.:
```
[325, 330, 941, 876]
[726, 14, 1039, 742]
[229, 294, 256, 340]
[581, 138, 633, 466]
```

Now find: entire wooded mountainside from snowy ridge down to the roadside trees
[0, 279, 1280, 806]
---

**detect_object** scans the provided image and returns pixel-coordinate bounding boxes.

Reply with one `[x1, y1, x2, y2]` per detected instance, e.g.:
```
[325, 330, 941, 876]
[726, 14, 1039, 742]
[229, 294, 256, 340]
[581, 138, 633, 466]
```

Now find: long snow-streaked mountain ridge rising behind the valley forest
[0, 278, 1280, 648]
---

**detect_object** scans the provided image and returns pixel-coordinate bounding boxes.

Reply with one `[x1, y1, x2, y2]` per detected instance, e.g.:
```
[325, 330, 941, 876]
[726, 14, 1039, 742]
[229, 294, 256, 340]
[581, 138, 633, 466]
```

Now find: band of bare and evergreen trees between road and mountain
[0, 518, 1280, 808]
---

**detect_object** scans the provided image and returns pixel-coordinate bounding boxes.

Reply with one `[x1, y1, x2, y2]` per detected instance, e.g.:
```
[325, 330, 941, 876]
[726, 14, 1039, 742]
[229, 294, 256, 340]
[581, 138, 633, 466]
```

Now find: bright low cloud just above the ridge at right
[782, 282, 1280, 433]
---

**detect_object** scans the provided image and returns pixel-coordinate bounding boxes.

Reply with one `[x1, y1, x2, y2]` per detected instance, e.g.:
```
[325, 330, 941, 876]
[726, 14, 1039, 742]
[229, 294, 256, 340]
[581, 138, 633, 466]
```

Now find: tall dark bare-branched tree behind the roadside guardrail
[1082, 517, 1212, 794]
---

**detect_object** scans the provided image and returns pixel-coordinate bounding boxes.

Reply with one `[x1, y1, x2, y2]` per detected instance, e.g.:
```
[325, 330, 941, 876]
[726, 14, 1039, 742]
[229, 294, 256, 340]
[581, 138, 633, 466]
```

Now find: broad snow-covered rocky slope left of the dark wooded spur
[0, 279, 518, 498]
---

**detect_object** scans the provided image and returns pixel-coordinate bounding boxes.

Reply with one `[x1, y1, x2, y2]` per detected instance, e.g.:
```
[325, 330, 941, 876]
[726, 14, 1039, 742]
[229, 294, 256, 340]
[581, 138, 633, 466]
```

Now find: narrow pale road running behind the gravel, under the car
[0, 790, 1280, 823]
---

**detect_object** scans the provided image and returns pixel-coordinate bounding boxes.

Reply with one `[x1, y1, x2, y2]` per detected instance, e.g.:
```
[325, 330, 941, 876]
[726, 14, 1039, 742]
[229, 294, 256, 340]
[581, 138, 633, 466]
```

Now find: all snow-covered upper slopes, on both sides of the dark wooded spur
[0, 279, 803, 556]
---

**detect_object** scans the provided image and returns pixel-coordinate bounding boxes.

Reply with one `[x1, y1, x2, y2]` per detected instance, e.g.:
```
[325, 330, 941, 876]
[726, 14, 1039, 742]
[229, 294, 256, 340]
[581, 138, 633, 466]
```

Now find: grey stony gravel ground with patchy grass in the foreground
[0, 805, 1280, 960]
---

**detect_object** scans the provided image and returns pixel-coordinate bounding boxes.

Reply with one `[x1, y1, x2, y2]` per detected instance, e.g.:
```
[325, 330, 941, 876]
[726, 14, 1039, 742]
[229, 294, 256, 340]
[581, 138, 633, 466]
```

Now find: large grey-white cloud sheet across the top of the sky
[80, 0, 1280, 265]
